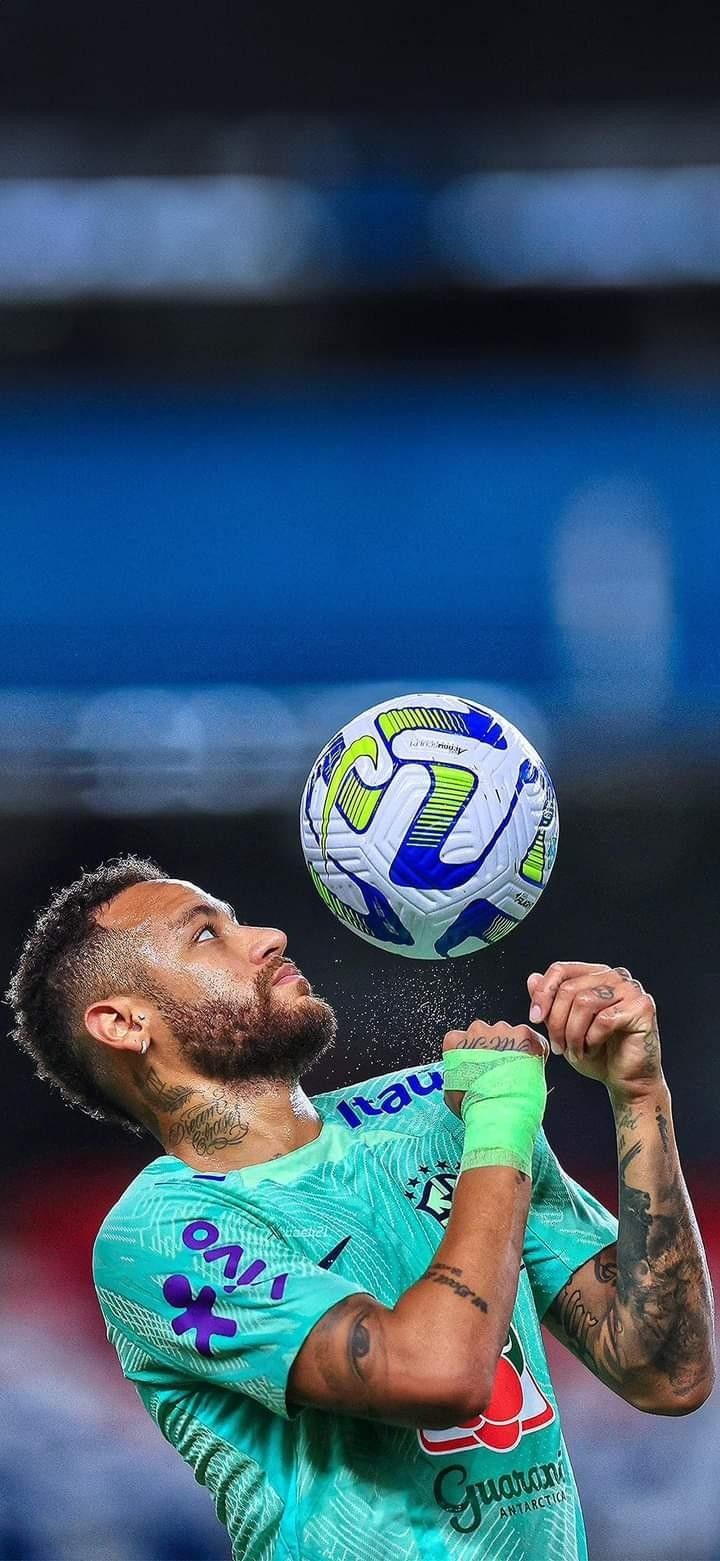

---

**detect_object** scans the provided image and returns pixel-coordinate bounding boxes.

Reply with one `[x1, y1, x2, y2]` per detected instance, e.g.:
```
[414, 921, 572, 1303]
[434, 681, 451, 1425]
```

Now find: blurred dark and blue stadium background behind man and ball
[0, 0, 720, 1561]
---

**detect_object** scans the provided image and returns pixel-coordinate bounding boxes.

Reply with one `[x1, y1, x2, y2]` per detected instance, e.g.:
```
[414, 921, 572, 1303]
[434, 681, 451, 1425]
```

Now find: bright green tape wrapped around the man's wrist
[444, 1049, 547, 1175]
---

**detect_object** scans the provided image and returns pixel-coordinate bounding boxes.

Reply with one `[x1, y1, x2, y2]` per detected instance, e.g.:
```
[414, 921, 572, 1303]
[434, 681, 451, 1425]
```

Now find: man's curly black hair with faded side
[5, 855, 167, 1133]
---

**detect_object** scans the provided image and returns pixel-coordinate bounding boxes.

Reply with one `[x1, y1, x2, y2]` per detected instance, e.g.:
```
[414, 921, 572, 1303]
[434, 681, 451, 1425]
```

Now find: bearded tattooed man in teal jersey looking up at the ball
[9, 857, 712, 1561]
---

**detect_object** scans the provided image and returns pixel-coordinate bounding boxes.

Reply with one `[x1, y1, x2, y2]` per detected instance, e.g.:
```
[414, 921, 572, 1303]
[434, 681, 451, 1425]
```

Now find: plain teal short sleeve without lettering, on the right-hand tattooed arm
[523, 1132, 617, 1317]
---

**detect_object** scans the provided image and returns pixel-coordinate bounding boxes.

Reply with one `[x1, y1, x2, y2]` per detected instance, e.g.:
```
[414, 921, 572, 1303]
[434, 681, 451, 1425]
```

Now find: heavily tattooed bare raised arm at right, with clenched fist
[528, 965, 714, 1414]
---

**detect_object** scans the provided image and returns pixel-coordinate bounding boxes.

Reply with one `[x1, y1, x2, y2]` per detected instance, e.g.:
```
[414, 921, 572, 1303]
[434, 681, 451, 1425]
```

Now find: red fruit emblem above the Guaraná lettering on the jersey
[417, 1328, 554, 1456]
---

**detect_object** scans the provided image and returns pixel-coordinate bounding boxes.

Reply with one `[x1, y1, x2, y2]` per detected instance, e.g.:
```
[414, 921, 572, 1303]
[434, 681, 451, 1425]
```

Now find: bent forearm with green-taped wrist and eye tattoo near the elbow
[289, 1021, 545, 1428]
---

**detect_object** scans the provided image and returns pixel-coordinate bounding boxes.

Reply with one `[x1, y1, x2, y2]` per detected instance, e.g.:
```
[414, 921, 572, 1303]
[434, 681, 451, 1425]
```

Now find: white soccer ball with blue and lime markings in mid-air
[300, 693, 558, 960]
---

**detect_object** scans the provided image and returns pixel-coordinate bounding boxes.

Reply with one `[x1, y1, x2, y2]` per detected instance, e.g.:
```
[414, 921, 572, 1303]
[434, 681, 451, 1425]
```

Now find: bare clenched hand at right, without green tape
[528, 960, 664, 1099]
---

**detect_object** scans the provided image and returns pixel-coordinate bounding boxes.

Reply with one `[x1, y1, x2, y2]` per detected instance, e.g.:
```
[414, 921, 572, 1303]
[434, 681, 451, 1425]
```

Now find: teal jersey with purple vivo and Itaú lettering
[94, 1066, 617, 1561]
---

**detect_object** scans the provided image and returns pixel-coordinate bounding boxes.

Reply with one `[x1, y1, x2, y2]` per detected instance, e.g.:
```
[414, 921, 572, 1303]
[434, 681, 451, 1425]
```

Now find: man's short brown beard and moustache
[156, 966, 337, 1085]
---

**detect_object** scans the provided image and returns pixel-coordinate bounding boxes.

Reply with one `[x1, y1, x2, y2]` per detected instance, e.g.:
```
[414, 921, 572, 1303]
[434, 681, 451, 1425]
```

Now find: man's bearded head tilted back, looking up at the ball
[8, 855, 334, 1132]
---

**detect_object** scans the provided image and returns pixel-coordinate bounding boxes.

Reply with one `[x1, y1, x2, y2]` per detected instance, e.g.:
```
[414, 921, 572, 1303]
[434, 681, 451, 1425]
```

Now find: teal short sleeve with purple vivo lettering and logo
[94, 1204, 364, 1419]
